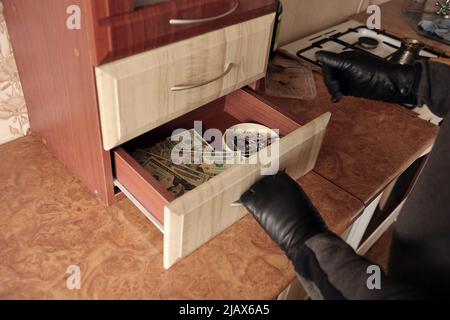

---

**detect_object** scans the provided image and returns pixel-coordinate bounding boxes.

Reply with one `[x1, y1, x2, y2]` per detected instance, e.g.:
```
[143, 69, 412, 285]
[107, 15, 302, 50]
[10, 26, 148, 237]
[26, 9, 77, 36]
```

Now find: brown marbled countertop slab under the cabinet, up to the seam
[0, 136, 364, 299]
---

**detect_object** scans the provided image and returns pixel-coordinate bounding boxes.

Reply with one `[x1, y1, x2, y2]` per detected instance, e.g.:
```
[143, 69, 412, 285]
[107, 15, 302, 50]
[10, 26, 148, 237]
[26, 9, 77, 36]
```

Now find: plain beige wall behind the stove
[280, 0, 388, 45]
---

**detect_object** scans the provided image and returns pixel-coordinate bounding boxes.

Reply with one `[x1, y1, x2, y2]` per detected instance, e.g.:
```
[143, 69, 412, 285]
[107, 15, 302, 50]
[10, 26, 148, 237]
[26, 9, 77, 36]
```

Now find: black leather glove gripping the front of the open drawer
[240, 172, 328, 260]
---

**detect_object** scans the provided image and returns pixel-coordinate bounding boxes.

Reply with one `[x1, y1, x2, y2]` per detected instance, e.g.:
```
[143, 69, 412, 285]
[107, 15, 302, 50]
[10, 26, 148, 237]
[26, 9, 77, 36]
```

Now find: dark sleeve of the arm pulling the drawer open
[293, 232, 425, 300]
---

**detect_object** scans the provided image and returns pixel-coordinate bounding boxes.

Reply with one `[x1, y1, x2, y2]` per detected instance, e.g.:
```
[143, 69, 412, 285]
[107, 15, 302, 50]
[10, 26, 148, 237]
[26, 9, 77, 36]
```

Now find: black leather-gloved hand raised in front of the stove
[316, 51, 422, 105]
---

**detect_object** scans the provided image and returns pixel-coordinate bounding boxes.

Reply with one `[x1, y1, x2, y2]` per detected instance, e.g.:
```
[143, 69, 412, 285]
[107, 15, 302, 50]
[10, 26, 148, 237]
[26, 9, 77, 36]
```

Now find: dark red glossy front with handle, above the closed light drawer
[83, 0, 276, 65]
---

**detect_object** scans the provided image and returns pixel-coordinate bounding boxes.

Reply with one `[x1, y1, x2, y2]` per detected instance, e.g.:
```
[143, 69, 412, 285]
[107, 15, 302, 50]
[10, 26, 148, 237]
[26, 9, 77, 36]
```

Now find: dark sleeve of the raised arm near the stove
[417, 61, 450, 118]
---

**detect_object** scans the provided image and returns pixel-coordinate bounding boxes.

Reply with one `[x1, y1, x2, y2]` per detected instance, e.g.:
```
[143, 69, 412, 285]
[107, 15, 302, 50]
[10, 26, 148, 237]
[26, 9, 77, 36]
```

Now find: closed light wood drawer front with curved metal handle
[95, 14, 274, 150]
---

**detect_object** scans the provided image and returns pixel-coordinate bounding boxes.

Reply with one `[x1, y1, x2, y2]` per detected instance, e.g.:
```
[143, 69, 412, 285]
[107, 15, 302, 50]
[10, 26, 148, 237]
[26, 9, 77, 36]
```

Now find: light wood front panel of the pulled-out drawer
[164, 113, 330, 268]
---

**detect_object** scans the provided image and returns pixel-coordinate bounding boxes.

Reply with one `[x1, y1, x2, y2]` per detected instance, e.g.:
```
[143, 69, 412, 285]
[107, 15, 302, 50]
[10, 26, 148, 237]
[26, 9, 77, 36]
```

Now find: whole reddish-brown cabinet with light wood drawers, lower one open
[4, 0, 329, 267]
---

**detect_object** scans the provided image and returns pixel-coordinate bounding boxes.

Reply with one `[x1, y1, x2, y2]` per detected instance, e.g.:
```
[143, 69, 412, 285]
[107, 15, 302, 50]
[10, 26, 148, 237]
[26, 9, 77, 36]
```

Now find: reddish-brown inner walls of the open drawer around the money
[114, 90, 300, 225]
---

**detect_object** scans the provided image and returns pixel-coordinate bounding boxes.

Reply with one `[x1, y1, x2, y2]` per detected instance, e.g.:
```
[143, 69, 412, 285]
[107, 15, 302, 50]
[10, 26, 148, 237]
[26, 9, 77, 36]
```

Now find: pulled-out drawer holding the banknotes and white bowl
[113, 90, 330, 268]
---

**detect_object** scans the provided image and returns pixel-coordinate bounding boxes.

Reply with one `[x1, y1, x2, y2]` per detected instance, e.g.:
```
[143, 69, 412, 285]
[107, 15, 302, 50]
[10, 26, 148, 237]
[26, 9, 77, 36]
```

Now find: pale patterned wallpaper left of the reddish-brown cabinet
[0, 2, 29, 144]
